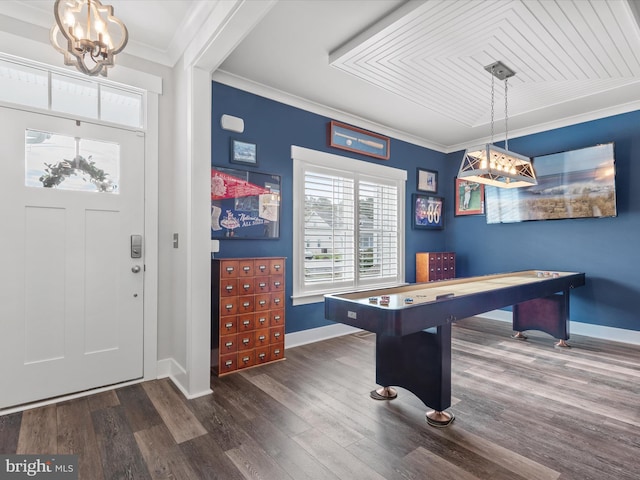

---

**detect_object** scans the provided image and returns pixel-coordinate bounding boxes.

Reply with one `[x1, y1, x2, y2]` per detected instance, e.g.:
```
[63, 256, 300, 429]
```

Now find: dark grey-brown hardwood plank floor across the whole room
[0, 318, 640, 480]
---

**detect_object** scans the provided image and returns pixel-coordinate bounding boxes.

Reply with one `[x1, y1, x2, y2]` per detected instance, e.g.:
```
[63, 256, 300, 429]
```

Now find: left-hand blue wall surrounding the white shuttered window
[211, 82, 446, 332]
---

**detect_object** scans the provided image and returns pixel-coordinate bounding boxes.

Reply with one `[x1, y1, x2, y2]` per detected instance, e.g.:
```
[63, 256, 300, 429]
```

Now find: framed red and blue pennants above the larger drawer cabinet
[211, 166, 281, 240]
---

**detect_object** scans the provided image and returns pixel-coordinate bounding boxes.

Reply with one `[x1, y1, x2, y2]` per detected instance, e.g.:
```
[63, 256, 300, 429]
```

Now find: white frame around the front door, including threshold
[0, 92, 162, 416]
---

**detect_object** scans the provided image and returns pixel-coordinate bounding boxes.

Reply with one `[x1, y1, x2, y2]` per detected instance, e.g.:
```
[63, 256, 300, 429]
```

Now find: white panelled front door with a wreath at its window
[0, 107, 144, 408]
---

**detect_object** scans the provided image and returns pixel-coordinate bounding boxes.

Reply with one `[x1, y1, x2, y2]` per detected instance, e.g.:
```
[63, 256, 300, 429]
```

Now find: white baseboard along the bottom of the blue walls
[285, 310, 640, 348]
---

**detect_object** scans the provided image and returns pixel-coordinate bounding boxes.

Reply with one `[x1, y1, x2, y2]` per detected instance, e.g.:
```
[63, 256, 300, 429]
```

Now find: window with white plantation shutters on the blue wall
[292, 147, 406, 305]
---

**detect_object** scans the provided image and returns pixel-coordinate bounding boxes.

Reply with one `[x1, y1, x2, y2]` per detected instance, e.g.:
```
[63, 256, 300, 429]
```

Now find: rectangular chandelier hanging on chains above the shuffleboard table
[458, 62, 538, 188]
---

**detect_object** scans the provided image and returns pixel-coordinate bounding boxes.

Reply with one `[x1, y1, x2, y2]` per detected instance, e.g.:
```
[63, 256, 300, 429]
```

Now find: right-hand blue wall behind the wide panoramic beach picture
[447, 111, 640, 330]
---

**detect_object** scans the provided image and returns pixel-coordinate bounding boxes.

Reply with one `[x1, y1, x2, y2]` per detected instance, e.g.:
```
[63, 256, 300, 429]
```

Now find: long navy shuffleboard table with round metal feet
[324, 270, 585, 427]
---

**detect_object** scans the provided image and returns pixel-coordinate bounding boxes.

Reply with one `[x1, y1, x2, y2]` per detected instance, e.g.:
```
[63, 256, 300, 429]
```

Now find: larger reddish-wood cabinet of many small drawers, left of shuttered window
[211, 257, 285, 376]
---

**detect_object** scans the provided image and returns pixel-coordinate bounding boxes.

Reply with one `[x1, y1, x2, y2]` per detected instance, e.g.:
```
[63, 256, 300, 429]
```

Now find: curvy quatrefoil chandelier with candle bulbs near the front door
[49, 0, 129, 77]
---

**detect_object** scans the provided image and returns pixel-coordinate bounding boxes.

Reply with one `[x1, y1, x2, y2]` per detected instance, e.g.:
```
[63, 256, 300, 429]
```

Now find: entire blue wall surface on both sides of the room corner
[211, 82, 640, 332]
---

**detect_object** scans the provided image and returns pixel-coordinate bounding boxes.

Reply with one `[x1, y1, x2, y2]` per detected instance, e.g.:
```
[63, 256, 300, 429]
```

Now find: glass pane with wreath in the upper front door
[25, 130, 120, 193]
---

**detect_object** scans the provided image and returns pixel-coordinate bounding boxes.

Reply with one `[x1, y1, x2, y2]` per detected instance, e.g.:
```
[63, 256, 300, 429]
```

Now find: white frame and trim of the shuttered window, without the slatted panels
[291, 145, 407, 306]
